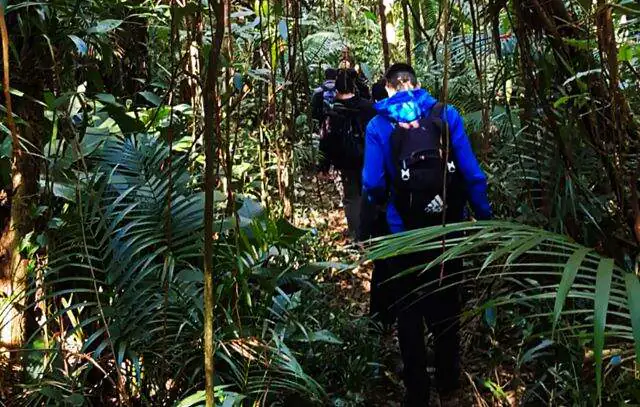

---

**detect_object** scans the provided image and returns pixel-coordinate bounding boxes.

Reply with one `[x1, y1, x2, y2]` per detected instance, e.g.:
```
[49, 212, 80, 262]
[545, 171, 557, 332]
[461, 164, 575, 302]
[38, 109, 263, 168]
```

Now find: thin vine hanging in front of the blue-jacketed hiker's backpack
[438, 0, 451, 286]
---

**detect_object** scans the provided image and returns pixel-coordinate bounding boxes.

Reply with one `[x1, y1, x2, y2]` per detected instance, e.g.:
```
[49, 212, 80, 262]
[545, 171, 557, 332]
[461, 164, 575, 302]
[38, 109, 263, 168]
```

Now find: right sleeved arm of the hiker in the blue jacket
[446, 106, 492, 220]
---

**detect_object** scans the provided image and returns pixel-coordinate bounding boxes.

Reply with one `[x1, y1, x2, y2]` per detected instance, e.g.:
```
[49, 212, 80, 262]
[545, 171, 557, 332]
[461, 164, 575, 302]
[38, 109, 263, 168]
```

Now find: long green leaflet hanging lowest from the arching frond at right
[593, 259, 614, 400]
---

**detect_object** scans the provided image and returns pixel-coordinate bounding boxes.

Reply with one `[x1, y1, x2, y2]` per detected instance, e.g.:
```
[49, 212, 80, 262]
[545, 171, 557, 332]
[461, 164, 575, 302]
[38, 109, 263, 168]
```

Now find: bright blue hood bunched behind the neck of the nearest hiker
[374, 89, 437, 123]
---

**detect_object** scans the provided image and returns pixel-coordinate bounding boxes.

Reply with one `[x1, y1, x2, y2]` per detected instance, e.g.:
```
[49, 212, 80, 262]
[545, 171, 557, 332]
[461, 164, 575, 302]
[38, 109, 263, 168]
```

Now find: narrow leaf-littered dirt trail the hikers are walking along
[295, 173, 517, 407]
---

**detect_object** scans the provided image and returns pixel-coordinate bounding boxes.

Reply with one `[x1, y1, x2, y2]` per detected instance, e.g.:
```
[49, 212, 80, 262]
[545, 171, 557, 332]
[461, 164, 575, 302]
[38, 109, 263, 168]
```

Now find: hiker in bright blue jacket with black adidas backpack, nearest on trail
[361, 64, 492, 407]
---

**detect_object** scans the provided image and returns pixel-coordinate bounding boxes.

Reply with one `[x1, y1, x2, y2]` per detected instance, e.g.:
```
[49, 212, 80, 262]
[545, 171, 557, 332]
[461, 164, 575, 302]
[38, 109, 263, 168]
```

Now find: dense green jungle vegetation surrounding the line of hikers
[0, 0, 640, 407]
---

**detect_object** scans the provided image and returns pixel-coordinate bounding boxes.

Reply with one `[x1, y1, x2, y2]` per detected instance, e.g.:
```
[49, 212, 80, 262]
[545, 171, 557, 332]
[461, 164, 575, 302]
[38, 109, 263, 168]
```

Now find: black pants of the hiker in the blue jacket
[391, 253, 461, 407]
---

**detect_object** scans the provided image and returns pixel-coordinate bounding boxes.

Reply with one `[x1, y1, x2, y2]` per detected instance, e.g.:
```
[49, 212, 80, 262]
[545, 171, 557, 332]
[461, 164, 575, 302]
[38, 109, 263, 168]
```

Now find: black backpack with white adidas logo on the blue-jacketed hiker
[391, 103, 466, 229]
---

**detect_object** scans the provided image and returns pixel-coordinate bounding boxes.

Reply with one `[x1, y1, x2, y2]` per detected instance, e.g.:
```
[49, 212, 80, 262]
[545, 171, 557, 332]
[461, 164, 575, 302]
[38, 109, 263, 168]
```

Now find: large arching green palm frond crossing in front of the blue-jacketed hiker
[368, 221, 640, 396]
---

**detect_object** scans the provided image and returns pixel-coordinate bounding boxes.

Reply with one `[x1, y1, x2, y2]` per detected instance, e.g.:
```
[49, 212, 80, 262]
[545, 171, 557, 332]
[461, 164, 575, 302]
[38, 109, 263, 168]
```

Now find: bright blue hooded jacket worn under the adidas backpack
[362, 89, 491, 233]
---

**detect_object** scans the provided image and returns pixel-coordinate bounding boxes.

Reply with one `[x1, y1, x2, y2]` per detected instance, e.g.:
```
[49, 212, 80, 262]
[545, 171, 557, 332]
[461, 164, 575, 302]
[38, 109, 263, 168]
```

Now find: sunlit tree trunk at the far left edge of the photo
[0, 4, 44, 358]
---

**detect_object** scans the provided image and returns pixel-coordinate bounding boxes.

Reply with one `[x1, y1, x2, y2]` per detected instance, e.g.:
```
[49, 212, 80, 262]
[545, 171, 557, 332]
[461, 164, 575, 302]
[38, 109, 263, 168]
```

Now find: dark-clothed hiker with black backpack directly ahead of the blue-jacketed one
[319, 69, 376, 240]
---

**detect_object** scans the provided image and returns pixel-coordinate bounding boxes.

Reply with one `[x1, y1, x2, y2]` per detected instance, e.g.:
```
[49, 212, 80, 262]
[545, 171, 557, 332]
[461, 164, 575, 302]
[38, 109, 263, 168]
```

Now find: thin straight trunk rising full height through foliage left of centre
[203, 0, 225, 407]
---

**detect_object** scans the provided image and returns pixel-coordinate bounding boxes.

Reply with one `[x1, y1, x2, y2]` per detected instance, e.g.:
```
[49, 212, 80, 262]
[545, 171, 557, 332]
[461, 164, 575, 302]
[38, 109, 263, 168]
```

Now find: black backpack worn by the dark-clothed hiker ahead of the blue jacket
[323, 101, 364, 170]
